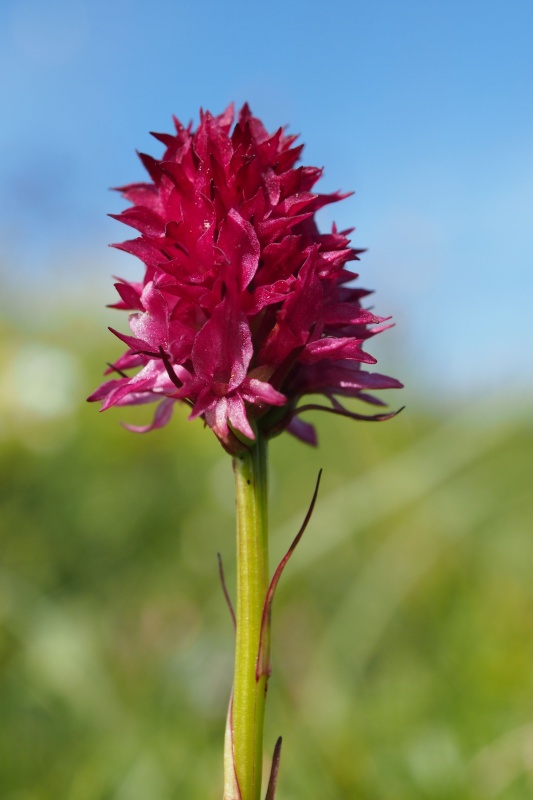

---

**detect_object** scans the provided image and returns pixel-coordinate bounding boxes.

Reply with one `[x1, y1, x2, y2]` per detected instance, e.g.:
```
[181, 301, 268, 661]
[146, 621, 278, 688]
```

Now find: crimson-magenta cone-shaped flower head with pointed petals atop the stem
[89, 105, 401, 453]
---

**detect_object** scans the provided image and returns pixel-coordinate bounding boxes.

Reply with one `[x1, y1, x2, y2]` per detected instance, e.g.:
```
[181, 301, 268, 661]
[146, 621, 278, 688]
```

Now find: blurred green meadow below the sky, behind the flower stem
[0, 312, 533, 800]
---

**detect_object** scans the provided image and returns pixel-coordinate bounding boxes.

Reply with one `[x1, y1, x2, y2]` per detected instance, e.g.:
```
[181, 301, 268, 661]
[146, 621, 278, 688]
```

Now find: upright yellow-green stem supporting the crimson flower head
[231, 434, 270, 800]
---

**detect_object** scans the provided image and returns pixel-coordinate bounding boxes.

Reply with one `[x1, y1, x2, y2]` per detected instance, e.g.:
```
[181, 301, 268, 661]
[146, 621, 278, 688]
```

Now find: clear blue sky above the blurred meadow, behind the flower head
[0, 0, 533, 398]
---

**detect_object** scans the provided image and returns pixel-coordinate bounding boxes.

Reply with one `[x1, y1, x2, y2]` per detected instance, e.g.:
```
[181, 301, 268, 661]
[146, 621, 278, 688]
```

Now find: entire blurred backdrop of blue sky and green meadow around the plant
[0, 0, 533, 800]
